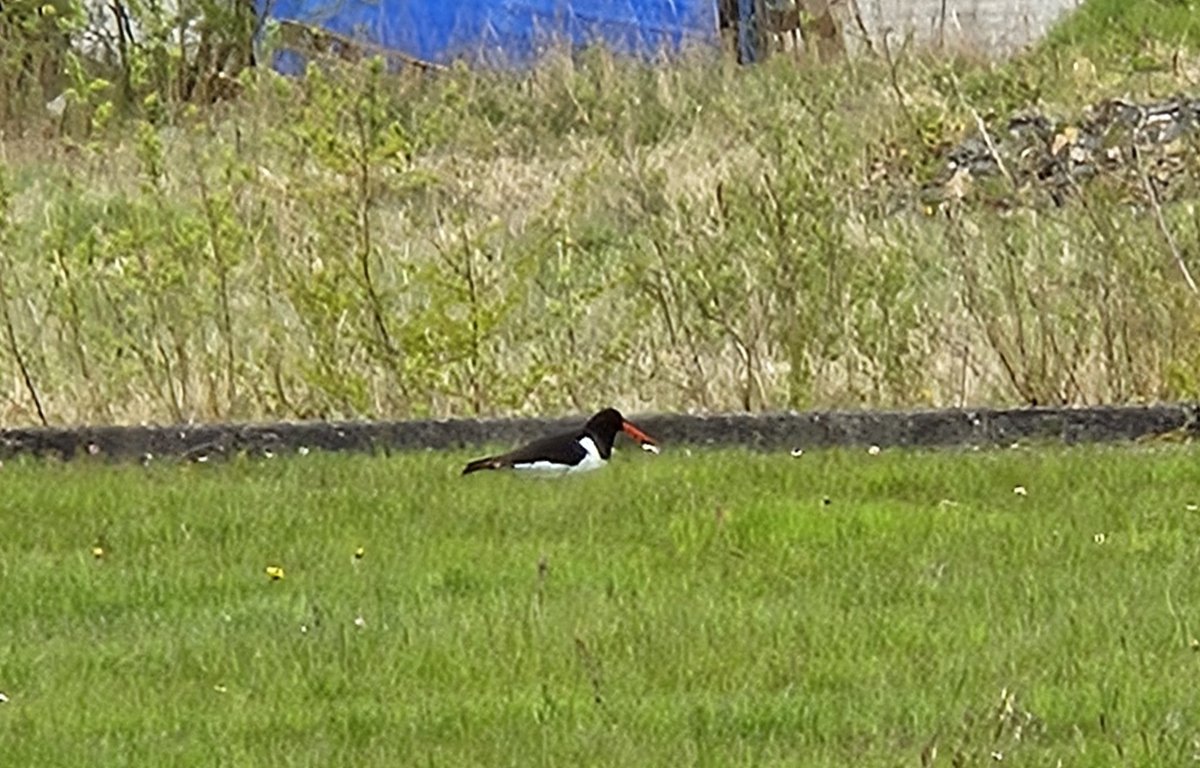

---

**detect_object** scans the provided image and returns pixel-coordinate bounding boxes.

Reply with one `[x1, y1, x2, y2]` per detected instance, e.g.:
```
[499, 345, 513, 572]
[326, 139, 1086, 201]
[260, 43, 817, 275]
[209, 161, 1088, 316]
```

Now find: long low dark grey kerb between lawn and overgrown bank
[0, 403, 1200, 461]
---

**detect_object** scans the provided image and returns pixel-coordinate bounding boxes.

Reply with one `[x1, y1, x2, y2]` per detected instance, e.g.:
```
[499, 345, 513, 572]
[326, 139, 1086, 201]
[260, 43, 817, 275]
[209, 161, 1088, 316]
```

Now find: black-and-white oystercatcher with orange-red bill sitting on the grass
[462, 408, 659, 475]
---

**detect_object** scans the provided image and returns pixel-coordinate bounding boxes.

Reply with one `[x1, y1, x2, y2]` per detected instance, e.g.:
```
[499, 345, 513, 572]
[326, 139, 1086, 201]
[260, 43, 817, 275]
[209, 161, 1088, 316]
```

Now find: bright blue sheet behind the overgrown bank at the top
[257, 0, 719, 66]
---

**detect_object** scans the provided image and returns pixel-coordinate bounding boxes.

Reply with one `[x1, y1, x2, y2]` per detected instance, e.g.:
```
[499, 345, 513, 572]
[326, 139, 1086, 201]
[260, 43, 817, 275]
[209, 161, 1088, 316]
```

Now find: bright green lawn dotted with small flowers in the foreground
[0, 445, 1200, 768]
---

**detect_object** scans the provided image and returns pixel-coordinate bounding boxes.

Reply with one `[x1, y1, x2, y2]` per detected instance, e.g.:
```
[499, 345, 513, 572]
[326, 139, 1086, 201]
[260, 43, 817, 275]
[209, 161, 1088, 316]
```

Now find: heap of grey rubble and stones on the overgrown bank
[922, 96, 1200, 205]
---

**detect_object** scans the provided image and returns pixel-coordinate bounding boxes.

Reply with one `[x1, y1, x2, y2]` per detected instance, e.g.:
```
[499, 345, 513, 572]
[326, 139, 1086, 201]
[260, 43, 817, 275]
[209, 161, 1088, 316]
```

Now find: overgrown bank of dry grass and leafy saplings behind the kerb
[0, 12, 1200, 424]
